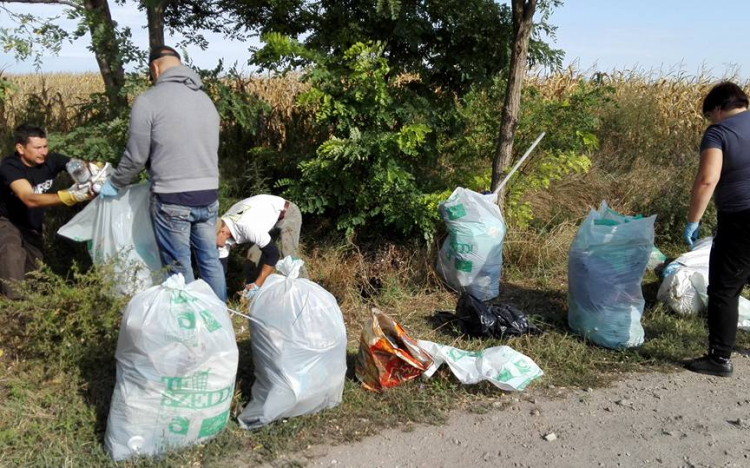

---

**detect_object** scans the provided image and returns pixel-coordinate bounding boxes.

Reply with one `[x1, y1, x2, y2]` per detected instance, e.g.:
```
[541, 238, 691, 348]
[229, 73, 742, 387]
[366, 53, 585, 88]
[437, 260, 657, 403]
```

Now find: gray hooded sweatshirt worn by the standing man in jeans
[111, 65, 219, 193]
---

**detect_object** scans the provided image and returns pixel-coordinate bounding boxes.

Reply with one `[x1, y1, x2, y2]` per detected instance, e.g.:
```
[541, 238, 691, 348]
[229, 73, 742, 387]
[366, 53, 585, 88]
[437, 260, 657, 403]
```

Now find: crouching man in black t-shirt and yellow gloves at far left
[0, 124, 94, 299]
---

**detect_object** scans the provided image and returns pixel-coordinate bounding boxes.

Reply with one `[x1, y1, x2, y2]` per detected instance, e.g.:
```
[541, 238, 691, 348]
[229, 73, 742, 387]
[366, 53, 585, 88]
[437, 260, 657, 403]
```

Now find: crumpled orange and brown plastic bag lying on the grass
[355, 307, 432, 392]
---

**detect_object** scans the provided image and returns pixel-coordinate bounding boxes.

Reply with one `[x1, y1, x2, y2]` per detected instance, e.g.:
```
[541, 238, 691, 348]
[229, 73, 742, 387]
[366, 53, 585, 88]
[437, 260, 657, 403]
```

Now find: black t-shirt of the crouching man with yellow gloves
[0, 153, 70, 232]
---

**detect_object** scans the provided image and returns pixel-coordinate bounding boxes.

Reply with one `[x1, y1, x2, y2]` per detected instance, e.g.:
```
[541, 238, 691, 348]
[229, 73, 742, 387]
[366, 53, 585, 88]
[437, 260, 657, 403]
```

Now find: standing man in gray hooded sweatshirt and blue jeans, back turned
[101, 46, 226, 301]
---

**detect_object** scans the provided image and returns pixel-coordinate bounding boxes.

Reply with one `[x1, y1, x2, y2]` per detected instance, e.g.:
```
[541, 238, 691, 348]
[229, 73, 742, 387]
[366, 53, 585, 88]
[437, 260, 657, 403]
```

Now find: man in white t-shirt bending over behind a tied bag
[216, 195, 307, 298]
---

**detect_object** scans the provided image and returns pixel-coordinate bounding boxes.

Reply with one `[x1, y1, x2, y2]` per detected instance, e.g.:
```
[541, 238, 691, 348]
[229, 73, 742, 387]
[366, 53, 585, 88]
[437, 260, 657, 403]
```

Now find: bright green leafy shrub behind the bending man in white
[261, 35, 436, 239]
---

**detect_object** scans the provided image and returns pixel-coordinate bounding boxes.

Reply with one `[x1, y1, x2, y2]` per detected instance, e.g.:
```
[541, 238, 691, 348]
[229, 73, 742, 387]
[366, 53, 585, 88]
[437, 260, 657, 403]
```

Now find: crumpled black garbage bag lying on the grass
[438, 293, 542, 338]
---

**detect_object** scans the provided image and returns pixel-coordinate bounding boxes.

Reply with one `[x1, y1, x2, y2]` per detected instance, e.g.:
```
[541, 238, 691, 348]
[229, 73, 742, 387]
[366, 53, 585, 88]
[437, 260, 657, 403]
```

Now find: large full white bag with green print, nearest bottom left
[104, 274, 239, 461]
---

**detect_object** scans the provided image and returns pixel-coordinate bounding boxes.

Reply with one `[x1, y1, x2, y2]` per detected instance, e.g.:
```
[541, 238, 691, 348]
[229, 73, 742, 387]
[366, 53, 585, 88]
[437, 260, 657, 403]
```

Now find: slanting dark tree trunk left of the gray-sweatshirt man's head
[83, 0, 128, 113]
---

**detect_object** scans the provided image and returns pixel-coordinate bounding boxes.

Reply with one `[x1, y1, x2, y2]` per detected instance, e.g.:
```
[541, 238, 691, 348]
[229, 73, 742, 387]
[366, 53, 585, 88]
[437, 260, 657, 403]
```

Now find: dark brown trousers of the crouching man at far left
[0, 217, 44, 299]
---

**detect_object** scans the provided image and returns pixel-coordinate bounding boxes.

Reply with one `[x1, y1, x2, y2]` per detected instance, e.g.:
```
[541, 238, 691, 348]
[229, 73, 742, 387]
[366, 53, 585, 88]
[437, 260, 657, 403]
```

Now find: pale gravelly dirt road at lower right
[274, 355, 750, 468]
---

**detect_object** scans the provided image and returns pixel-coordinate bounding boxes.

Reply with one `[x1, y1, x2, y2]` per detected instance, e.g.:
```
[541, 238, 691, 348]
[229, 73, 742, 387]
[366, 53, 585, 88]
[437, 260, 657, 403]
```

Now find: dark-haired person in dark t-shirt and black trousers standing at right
[684, 82, 750, 377]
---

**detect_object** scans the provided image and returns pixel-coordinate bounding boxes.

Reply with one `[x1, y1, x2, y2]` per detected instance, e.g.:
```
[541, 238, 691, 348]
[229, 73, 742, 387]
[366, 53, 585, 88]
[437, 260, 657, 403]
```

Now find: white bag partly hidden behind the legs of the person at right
[656, 237, 750, 330]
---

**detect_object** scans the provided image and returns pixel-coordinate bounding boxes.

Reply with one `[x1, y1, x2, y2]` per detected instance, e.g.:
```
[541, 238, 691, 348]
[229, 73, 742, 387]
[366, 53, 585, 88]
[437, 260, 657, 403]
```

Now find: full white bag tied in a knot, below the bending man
[238, 256, 346, 429]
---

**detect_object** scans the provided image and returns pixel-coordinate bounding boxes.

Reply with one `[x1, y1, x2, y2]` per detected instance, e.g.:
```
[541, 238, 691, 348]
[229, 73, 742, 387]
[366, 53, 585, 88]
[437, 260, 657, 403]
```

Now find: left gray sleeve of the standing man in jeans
[110, 96, 153, 189]
